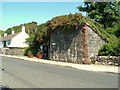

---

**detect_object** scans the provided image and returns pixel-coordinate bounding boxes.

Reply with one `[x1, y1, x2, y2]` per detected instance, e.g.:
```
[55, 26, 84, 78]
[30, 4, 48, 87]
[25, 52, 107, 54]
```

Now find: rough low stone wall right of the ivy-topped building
[90, 56, 120, 66]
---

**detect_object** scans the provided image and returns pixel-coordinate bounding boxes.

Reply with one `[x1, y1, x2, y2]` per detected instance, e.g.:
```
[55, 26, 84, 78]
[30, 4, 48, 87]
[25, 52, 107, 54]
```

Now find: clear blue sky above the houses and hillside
[0, 2, 85, 30]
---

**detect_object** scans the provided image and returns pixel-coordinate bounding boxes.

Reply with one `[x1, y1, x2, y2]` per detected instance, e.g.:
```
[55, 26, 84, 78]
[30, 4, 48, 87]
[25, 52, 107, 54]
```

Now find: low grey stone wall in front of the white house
[5, 48, 25, 56]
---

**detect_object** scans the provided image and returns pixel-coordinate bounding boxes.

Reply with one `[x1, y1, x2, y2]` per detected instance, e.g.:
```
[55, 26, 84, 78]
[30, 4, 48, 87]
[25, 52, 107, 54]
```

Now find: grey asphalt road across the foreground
[2, 57, 118, 88]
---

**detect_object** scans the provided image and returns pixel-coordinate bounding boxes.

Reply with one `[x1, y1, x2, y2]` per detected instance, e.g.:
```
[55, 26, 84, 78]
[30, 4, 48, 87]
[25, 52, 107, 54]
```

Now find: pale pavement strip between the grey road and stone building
[0, 54, 120, 74]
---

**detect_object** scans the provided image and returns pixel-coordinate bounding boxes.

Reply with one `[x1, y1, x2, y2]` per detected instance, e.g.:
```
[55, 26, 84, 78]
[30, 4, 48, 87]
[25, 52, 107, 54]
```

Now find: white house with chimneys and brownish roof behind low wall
[0, 25, 29, 48]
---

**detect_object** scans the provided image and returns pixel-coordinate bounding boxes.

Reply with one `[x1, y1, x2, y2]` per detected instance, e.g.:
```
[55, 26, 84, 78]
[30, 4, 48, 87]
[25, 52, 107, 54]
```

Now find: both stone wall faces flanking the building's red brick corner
[50, 25, 105, 63]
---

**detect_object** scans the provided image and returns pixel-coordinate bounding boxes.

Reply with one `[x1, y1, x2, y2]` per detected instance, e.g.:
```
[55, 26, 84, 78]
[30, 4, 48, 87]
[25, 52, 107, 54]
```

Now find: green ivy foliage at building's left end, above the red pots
[25, 23, 50, 55]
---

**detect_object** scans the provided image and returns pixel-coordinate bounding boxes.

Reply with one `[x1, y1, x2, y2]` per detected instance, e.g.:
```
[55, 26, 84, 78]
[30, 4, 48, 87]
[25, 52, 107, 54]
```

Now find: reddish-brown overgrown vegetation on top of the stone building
[47, 13, 85, 31]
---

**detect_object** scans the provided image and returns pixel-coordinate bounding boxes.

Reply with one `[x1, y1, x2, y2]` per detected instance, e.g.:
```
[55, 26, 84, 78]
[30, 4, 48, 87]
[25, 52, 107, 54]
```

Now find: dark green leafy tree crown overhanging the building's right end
[77, 2, 120, 28]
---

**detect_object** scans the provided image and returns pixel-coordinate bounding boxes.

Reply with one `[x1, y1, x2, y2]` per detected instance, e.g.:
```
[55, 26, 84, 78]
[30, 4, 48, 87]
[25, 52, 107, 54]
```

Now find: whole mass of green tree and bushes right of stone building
[77, 2, 120, 55]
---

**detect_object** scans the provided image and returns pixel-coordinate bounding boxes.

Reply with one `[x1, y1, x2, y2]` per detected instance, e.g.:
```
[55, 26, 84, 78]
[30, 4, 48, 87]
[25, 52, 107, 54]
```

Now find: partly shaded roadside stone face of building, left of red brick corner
[50, 28, 82, 63]
